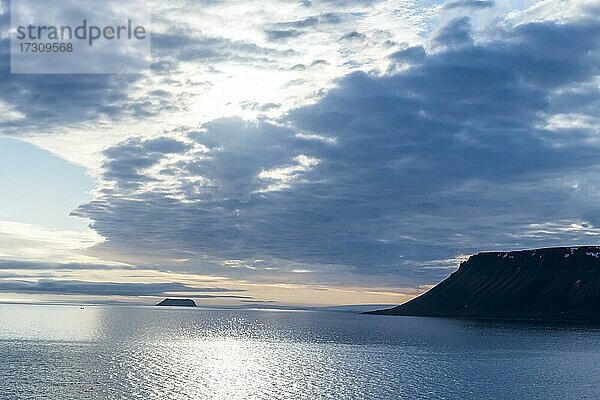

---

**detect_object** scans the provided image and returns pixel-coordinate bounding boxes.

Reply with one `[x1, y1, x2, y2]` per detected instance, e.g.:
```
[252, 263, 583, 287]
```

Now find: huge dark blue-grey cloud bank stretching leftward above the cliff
[77, 14, 600, 284]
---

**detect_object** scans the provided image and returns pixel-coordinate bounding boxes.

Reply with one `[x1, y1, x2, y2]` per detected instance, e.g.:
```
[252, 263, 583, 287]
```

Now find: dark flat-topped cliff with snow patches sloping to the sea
[373, 246, 600, 322]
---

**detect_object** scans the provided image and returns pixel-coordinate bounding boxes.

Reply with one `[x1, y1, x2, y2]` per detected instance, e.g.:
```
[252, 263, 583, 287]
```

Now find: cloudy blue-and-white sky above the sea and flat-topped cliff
[0, 0, 600, 306]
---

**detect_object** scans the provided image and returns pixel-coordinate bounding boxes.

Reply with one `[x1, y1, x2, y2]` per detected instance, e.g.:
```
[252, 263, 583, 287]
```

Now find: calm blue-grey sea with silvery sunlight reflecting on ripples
[0, 305, 600, 400]
